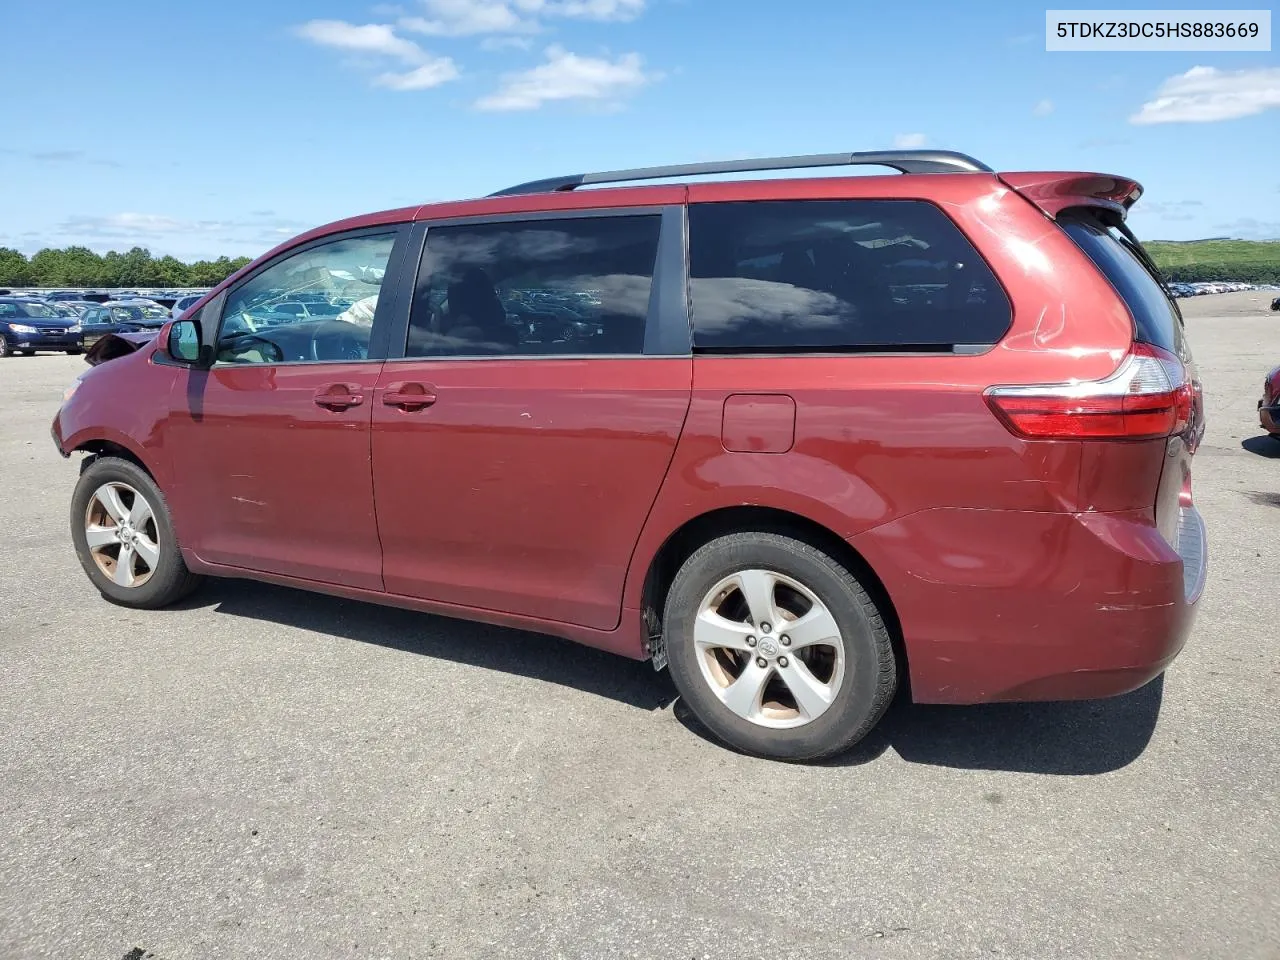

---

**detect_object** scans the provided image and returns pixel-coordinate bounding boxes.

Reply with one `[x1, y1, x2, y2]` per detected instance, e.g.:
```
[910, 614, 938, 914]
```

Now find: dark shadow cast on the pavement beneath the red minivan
[192, 580, 1165, 774]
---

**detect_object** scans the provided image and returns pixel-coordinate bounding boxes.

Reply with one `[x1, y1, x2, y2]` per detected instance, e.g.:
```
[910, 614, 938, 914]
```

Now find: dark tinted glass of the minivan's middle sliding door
[407, 215, 660, 357]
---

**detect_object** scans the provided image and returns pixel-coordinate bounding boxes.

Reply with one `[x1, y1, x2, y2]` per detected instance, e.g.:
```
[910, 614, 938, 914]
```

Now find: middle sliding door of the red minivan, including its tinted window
[372, 206, 692, 630]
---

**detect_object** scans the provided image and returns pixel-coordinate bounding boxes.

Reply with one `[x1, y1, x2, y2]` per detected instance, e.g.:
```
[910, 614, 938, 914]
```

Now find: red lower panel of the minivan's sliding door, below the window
[372, 357, 692, 630]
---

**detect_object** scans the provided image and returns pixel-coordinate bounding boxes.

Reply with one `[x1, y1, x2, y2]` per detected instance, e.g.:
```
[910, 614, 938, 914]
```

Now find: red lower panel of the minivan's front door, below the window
[165, 362, 383, 590]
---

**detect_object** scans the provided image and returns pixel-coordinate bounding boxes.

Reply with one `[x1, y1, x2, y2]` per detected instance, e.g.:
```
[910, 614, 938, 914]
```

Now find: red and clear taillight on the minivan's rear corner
[987, 343, 1193, 440]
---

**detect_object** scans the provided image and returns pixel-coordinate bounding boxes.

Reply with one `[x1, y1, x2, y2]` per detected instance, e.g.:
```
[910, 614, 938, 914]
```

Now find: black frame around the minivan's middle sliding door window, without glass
[387, 204, 692, 364]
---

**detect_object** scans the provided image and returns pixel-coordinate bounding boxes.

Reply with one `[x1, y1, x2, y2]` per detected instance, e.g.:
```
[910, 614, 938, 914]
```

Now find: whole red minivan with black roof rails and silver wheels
[52, 151, 1206, 759]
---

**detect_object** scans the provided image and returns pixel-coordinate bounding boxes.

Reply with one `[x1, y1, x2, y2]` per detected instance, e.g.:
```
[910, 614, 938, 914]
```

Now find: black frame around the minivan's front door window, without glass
[202, 220, 413, 370]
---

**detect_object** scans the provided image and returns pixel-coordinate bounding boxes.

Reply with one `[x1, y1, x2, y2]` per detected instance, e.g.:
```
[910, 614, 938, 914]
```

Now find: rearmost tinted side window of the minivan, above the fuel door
[689, 200, 1012, 352]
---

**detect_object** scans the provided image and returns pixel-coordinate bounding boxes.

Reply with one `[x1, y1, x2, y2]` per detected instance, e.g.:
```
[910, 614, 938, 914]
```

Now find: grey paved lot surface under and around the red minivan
[0, 293, 1280, 960]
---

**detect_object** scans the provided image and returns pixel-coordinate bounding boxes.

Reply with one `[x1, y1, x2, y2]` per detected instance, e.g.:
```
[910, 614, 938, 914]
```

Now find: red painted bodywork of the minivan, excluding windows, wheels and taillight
[54, 165, 1208, 703]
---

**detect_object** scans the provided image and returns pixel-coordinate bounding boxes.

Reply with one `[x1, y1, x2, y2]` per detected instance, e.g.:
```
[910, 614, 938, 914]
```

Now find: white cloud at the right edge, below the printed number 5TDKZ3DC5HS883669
[1129, 67, 1280, 124]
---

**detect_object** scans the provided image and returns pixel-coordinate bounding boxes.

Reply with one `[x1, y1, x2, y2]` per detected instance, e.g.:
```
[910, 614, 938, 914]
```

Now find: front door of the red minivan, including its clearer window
[164, 225, 410, 590]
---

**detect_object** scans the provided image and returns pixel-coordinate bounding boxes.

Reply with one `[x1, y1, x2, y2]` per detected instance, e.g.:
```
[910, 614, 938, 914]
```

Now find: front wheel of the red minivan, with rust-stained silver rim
[70, 457, 201, 609]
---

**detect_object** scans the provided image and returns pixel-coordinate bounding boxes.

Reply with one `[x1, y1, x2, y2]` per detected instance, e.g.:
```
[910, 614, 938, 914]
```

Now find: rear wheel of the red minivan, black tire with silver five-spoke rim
[663, 532, 897, 760]
